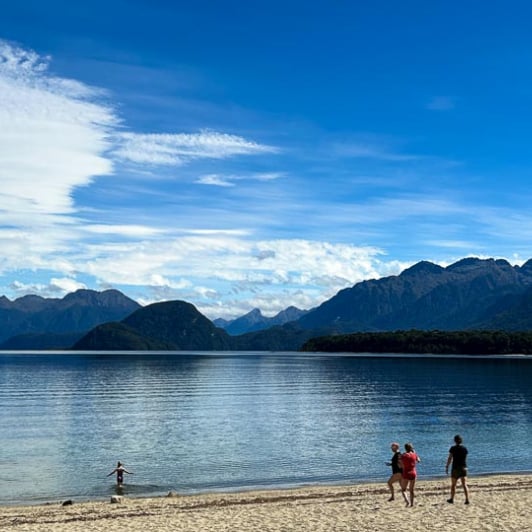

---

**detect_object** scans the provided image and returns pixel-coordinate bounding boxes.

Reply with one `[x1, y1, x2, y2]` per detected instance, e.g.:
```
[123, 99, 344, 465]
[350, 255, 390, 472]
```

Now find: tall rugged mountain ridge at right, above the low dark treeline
[295, 258, 532, 334]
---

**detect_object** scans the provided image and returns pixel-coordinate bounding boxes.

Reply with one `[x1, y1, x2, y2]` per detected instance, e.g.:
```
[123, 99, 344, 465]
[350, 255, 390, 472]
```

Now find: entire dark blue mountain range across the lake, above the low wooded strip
[0, 258, 532, 350]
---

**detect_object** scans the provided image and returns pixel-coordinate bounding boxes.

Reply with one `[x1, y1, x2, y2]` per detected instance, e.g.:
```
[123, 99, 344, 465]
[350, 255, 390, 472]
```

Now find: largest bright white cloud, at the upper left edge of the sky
[0, 41, 118, 221]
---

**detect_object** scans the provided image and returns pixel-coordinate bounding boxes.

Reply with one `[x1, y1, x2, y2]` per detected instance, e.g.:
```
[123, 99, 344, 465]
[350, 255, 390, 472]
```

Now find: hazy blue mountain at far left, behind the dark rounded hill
[0, 290, 140, 349]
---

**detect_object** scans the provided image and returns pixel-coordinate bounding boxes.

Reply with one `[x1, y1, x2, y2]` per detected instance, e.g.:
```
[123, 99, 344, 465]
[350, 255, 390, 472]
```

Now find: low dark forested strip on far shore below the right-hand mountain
[301, 330, 532, 355]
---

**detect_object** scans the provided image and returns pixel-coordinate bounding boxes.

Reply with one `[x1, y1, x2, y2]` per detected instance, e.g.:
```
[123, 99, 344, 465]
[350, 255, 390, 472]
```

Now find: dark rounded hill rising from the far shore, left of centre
[73, 301, 233, 351]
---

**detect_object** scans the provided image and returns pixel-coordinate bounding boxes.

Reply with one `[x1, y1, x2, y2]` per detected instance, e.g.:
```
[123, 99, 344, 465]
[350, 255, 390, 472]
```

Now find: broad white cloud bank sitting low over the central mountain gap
[70, 234, 405, 317]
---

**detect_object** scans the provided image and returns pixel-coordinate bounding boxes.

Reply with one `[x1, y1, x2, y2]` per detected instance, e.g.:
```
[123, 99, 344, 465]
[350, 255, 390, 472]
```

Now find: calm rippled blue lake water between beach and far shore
[0, 352, 532, 504]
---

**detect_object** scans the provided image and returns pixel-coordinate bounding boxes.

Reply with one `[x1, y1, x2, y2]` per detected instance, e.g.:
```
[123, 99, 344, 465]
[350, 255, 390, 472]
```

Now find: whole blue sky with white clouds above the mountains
[0, 0, 532, 319]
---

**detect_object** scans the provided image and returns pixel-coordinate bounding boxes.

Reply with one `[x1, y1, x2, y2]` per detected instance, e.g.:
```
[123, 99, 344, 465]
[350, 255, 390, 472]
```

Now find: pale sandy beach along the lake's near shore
[0, 475, 532, 532]
